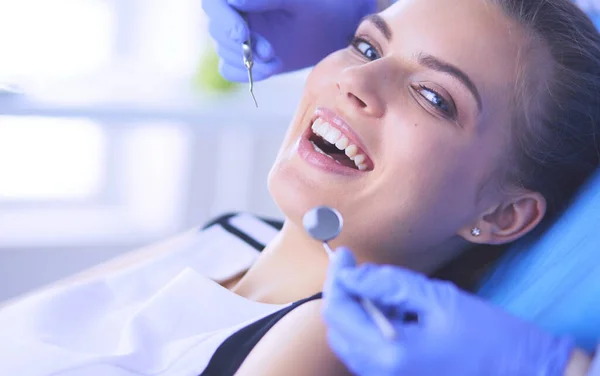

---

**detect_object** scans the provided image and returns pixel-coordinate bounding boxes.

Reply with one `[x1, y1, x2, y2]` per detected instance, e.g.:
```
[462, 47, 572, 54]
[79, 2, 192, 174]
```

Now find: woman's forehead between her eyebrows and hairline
[381, 0, 527, 97]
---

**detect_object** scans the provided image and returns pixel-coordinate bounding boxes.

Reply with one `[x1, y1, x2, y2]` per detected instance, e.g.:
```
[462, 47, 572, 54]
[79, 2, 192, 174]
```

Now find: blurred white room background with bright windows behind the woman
[0, 0, 306, 300]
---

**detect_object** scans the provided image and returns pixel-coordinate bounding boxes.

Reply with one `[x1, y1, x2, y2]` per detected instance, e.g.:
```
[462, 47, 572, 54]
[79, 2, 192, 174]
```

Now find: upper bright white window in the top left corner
[0, 0, 115, 81]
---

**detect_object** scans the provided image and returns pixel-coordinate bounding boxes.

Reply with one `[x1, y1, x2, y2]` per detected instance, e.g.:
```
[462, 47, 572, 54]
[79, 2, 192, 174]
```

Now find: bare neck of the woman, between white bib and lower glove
[232, 221, 329, 304]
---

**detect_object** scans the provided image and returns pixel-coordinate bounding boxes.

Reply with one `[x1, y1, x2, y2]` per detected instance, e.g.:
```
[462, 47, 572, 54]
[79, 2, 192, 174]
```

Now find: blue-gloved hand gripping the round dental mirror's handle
[323, 248, 574, 376]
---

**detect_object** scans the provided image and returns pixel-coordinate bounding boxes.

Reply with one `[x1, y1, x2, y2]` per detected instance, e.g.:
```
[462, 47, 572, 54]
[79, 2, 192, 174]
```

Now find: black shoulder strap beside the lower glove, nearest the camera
[200, 293, 322, 376]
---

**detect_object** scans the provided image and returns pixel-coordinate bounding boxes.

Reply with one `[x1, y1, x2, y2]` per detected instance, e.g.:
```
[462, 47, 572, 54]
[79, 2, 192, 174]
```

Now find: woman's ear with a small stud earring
[459, 192, 546, 245]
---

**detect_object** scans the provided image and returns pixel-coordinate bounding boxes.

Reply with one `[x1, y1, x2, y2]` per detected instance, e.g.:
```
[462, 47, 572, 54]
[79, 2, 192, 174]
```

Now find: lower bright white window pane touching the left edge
[0, 116, 106, 201]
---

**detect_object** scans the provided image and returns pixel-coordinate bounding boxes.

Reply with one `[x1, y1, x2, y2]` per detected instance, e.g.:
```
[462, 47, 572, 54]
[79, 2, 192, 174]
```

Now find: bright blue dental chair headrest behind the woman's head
[478, 171, 600, 351]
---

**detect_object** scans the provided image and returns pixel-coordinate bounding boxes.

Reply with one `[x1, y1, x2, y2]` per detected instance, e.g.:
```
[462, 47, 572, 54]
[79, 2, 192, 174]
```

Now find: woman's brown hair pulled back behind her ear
[436, 0, 600, 287]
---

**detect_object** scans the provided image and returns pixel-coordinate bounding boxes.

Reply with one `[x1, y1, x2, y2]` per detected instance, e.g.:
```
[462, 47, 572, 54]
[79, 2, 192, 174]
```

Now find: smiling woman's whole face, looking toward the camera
[269, 0, 536, 263]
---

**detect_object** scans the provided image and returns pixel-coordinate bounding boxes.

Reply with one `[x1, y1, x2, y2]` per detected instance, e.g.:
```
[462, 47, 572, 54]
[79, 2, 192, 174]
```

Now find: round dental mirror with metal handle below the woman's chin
[302, 206, 396, 340]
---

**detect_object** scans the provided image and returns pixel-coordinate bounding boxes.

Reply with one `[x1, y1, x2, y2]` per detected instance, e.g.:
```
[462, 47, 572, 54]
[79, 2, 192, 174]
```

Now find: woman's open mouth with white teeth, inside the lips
[308, 118, 370, 171]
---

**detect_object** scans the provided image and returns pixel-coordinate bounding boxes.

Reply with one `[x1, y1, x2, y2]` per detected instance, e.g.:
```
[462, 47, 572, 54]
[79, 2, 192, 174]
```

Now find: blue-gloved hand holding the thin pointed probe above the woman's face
[202, 0, 376, 82]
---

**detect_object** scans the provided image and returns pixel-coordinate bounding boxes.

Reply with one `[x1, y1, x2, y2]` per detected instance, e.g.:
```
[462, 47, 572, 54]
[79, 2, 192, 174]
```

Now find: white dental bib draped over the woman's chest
[0, 215, 287, 376]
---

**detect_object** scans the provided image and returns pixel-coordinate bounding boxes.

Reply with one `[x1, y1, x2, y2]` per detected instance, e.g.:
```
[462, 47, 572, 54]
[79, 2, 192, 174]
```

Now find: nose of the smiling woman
[336, 65, 385, 117]
